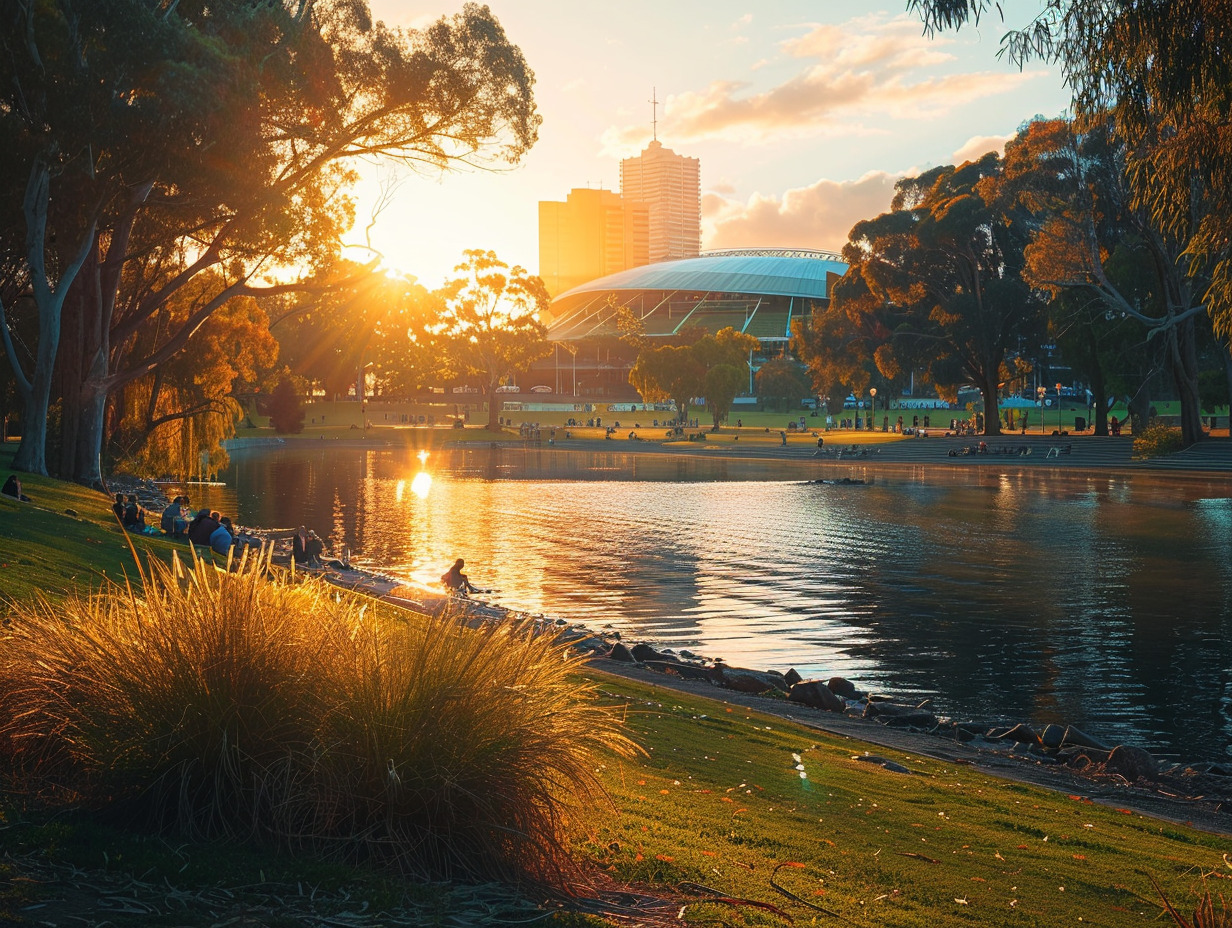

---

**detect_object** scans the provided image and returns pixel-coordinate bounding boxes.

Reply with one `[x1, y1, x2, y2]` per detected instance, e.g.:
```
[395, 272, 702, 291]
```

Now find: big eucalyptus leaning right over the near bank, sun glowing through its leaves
[7, 0, 540, 481]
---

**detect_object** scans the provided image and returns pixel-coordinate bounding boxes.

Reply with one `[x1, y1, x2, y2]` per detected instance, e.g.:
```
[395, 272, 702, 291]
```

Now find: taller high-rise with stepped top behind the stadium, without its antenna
[620, 139, 701, 264]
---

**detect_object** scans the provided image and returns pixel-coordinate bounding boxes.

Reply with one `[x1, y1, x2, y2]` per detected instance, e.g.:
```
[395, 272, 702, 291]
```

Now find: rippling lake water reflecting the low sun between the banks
[193, 444, 1232, 759]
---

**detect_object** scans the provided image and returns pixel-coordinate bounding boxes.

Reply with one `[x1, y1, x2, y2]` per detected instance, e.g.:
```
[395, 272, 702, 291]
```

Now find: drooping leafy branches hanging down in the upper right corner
[908, 0, 1232, 441]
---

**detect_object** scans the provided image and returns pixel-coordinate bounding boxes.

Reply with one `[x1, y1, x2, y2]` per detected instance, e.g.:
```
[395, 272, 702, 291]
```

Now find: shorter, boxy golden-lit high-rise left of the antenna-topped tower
[540, 189, 649, 297]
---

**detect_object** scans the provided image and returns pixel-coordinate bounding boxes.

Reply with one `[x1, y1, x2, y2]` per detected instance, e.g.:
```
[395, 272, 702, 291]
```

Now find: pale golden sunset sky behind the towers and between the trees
[347, 0, 1068, 286]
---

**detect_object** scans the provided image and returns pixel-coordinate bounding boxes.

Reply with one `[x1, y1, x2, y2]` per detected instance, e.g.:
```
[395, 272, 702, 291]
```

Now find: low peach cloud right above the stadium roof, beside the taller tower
[702, 171, 902, 251]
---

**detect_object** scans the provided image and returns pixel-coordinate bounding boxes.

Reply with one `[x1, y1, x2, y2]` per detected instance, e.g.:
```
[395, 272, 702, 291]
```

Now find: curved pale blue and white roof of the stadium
[548, 249, 848, 340]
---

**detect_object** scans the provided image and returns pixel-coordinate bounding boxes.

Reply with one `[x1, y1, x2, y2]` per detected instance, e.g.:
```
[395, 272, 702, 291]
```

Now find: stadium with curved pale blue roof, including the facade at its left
[530, 248, 846, 398]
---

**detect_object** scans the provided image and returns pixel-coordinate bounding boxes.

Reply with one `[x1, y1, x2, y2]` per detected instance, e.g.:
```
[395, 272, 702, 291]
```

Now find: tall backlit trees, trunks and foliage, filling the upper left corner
[0, 0, 540, 479]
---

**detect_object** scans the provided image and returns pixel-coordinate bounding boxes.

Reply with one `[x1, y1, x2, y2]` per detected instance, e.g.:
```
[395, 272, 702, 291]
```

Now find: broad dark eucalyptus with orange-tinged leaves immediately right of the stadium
[813, 153, 1045, 435]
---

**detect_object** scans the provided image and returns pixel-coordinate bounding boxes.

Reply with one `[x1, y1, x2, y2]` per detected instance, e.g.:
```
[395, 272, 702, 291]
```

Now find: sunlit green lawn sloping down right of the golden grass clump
[584, 679, 1232, 928]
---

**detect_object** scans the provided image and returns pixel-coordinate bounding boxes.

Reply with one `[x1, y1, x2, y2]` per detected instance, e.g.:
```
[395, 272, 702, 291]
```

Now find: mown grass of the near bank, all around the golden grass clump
[0, 446, 1232, 928]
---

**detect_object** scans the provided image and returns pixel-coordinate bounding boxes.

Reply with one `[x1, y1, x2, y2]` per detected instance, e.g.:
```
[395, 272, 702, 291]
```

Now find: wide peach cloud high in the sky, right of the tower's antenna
[602, 15, 1046, 148]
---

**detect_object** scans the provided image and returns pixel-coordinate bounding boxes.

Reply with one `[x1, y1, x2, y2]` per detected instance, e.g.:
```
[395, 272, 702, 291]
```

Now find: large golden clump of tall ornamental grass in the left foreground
[0, 556, 637, 882]
